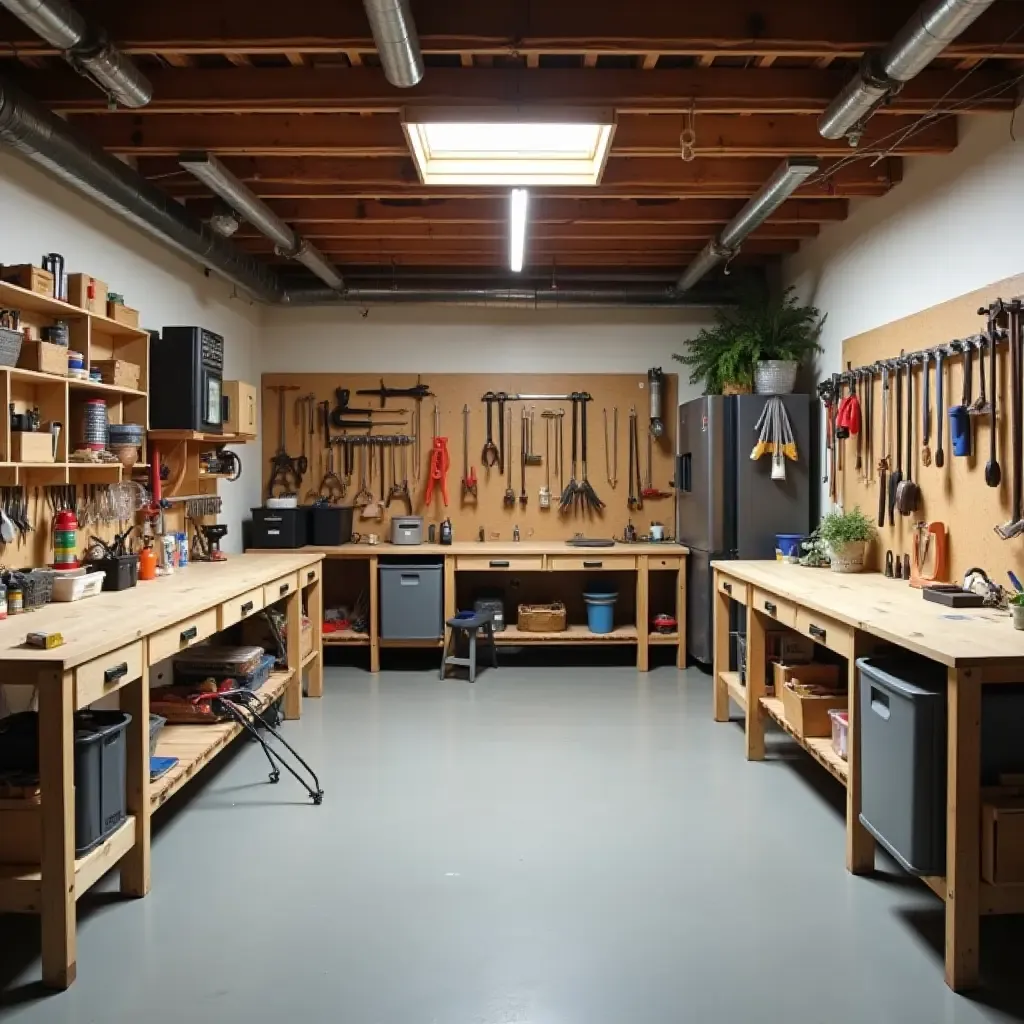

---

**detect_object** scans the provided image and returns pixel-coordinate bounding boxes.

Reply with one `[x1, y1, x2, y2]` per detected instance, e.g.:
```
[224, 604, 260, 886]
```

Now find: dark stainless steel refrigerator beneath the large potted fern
[676, 394, 811, 665]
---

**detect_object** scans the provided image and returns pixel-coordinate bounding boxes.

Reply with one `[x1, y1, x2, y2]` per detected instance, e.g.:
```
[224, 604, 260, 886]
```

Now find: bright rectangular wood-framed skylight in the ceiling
[401, 106, 615, 185]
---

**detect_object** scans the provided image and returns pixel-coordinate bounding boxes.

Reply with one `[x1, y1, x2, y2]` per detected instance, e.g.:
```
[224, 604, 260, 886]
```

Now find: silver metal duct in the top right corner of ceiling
[818, 0, 992, 139]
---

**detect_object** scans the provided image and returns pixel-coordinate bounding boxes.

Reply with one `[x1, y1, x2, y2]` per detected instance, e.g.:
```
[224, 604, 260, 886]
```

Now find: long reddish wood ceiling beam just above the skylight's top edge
[25, 68, 1014, 117]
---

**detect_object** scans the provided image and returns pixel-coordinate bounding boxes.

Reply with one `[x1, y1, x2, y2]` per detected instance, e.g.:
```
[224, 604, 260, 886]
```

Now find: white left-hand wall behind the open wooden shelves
[0, 153, 262, 551]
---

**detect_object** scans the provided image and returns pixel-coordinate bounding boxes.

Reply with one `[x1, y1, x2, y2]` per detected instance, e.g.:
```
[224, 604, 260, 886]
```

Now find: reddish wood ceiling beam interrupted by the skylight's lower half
[138, 157, 902, 198]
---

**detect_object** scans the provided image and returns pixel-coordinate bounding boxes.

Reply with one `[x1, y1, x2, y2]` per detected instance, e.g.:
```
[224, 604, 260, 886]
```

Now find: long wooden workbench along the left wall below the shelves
[0, 552, 323, 988]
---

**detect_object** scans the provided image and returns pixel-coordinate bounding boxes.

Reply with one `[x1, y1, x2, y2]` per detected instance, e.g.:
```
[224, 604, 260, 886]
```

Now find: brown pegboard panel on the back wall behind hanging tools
[262, 371, 678, 541]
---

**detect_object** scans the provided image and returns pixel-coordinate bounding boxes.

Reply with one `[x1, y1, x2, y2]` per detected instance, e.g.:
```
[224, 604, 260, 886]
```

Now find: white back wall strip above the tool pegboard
[262, 306, 710, 397]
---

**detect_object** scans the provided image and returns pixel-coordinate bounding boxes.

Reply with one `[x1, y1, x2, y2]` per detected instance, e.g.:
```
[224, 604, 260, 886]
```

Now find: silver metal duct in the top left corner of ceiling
[0, 0, 153, 108]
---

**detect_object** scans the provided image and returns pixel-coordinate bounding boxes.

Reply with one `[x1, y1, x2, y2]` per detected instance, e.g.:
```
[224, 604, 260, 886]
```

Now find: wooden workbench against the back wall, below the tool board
[268, 541, 689, 672]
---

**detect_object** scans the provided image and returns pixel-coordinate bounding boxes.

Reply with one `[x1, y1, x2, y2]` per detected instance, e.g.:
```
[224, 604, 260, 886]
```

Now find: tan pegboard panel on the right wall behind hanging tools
[840, 275, 1024, 585]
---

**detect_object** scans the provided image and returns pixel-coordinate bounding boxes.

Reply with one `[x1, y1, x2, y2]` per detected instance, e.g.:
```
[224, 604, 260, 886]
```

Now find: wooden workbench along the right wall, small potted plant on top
[713, 561, 1024, 990]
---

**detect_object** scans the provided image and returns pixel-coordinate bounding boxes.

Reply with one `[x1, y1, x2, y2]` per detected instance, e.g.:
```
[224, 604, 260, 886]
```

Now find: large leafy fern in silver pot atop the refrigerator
[673, 288, 825, 394]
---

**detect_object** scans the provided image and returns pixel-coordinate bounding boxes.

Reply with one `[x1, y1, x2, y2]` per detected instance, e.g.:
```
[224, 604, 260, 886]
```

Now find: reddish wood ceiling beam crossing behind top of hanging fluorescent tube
[182, 196, 849, 230]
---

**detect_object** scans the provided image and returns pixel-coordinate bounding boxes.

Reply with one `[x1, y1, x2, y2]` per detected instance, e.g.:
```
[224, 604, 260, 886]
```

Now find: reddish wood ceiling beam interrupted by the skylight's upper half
[69, 114, 956, 159]
